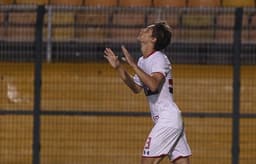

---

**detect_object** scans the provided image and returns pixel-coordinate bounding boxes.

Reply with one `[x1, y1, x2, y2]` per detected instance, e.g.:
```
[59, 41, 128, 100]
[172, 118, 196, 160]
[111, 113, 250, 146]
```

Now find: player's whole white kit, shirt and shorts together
[134, 51, 191, 161]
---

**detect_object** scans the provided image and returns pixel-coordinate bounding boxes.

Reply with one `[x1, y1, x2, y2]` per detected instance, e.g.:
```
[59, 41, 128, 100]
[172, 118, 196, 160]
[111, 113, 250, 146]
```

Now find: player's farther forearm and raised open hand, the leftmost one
[104, 48, 141, 93]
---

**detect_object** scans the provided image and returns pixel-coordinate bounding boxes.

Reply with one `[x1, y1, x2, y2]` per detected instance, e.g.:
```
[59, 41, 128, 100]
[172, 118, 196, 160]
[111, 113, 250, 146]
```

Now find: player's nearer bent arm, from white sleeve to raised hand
[122, 46, 165, 92]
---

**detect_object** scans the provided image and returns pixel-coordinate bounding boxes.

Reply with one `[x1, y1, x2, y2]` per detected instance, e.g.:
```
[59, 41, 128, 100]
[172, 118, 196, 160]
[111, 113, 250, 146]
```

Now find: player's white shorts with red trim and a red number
[142, 124, 191, 161]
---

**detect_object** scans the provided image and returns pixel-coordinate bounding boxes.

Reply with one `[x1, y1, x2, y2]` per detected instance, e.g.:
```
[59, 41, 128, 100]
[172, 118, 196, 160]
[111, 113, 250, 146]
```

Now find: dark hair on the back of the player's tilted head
[152, 22, 172, 51]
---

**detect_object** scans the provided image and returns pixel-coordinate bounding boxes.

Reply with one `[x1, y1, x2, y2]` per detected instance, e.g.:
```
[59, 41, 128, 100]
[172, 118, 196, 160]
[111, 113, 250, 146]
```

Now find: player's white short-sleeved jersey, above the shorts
[134, 51, 182, 128]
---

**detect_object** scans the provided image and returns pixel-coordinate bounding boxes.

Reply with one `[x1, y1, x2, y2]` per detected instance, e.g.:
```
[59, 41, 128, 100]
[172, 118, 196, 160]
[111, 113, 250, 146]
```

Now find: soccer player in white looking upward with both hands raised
[104, 22, 191, 164]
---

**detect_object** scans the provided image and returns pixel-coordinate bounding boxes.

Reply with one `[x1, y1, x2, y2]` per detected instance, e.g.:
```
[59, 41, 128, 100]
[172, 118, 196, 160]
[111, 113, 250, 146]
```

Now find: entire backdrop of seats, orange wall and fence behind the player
[0, 0, 256, 164]
